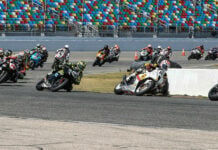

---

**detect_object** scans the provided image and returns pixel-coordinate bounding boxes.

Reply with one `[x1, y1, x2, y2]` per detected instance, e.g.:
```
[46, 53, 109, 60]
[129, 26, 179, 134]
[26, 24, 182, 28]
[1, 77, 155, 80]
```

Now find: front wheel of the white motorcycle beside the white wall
[135, 79, 155, 96]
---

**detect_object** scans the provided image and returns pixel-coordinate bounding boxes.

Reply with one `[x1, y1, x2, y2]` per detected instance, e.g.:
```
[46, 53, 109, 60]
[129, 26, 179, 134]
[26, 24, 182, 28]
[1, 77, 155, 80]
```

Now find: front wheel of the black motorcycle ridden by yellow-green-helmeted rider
[50, 78, 69, 92]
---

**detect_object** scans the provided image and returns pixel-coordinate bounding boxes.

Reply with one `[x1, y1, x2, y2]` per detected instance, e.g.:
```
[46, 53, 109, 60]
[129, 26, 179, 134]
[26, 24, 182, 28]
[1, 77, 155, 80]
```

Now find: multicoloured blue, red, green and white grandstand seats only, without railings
[0, 0, 218, 29]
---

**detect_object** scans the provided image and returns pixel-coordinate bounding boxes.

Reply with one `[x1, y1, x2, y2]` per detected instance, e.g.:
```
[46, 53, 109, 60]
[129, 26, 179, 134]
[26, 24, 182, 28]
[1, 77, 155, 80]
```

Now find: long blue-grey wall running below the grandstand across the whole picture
[0, 36, 218, 51]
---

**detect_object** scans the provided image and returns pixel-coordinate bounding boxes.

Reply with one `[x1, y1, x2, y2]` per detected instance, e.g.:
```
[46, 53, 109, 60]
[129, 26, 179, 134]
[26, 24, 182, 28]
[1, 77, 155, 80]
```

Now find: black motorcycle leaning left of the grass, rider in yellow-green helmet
[36, 66, 82, 92]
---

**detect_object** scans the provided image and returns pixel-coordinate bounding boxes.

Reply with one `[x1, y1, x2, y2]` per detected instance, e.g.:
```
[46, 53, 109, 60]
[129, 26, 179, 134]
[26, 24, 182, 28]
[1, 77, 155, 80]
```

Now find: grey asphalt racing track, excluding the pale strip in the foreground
[0, 52, 218, 131]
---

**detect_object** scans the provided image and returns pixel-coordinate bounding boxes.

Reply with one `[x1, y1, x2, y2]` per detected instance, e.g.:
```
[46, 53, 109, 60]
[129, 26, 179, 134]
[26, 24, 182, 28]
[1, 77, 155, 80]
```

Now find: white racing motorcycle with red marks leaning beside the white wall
[114, 67, 169, 96]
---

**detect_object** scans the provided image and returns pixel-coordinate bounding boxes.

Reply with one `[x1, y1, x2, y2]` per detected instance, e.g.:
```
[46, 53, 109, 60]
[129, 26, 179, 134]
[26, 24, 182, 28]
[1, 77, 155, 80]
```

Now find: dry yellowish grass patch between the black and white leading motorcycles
[74, 72, 127, 93]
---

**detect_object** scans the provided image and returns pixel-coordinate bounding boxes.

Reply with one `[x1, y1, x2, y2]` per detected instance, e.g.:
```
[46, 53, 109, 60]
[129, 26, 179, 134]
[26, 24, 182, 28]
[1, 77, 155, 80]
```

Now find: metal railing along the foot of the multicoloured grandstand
[0, 23, 218, 33]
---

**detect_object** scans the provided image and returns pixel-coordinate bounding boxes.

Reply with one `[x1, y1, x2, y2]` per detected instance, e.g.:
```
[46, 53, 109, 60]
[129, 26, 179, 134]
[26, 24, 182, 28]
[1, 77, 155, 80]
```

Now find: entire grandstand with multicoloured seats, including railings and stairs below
[0, 0, 218, 36]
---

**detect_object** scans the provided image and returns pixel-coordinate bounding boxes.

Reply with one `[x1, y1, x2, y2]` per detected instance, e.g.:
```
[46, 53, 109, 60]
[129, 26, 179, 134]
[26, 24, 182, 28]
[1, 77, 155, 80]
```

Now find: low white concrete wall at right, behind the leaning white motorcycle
[168, 69, 218, 96]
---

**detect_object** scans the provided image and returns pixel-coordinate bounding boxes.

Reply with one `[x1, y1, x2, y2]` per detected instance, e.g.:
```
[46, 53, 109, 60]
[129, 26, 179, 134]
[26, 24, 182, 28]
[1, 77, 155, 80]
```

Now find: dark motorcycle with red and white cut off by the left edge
[0, 57, 19, 83]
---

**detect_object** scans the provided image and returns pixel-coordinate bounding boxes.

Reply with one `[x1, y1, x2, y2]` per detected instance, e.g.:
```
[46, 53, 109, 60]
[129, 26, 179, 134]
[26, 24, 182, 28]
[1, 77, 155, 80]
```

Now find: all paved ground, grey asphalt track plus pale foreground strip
[0, 37, 218, 150]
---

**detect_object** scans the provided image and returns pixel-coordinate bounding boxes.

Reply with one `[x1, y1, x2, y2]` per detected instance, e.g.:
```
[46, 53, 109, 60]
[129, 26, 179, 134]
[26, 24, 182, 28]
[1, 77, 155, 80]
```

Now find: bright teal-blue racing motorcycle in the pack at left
[29, 52, 43, 70]
